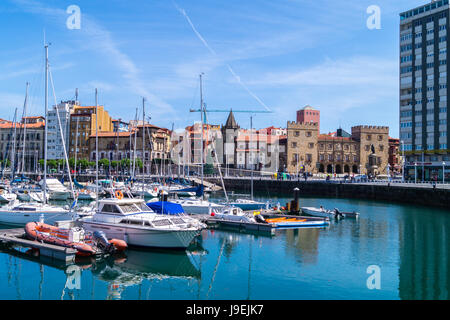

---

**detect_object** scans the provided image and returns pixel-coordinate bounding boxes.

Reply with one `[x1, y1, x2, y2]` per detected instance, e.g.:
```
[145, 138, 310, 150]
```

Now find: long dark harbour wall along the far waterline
[207, 178, 450, 209]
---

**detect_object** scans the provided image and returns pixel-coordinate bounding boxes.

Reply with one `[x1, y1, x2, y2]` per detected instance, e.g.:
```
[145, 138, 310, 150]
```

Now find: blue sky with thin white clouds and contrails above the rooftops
[0, 0, 426, 137]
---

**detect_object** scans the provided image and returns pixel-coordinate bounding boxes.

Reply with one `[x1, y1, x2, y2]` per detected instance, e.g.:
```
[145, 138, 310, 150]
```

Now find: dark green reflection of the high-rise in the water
[399, 209, 450, 300]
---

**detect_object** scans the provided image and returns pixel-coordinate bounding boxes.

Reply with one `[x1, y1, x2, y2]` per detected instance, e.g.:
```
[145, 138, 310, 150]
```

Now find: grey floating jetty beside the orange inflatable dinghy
[0, 228, 77, 263]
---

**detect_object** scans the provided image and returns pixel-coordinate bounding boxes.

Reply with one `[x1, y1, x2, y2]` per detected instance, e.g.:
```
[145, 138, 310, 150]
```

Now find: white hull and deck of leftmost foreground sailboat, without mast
[0, 200, 76, 226]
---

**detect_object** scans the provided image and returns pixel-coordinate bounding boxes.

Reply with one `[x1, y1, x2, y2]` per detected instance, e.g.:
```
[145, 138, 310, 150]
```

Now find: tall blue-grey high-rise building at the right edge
[399, 0, 450, 180]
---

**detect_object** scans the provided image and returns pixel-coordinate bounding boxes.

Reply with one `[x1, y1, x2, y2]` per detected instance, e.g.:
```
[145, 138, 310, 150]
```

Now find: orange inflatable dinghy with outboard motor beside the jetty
[25, 222, 127, 256]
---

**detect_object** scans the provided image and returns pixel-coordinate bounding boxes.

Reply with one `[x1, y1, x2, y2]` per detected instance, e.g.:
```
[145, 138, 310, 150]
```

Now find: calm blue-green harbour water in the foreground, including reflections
[0, 197, 450, 300]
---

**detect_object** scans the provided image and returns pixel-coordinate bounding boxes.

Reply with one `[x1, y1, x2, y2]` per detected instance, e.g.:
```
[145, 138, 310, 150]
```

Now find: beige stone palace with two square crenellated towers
[287, 122, 389, 175]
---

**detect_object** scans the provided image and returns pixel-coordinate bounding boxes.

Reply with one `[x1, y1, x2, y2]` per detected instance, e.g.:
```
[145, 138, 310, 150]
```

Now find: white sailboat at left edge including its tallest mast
[0, 44, 76, 226]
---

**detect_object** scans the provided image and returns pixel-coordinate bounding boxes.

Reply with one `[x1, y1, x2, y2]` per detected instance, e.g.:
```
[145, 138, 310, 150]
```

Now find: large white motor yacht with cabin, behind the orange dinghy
[80, 198, 202, 249]
